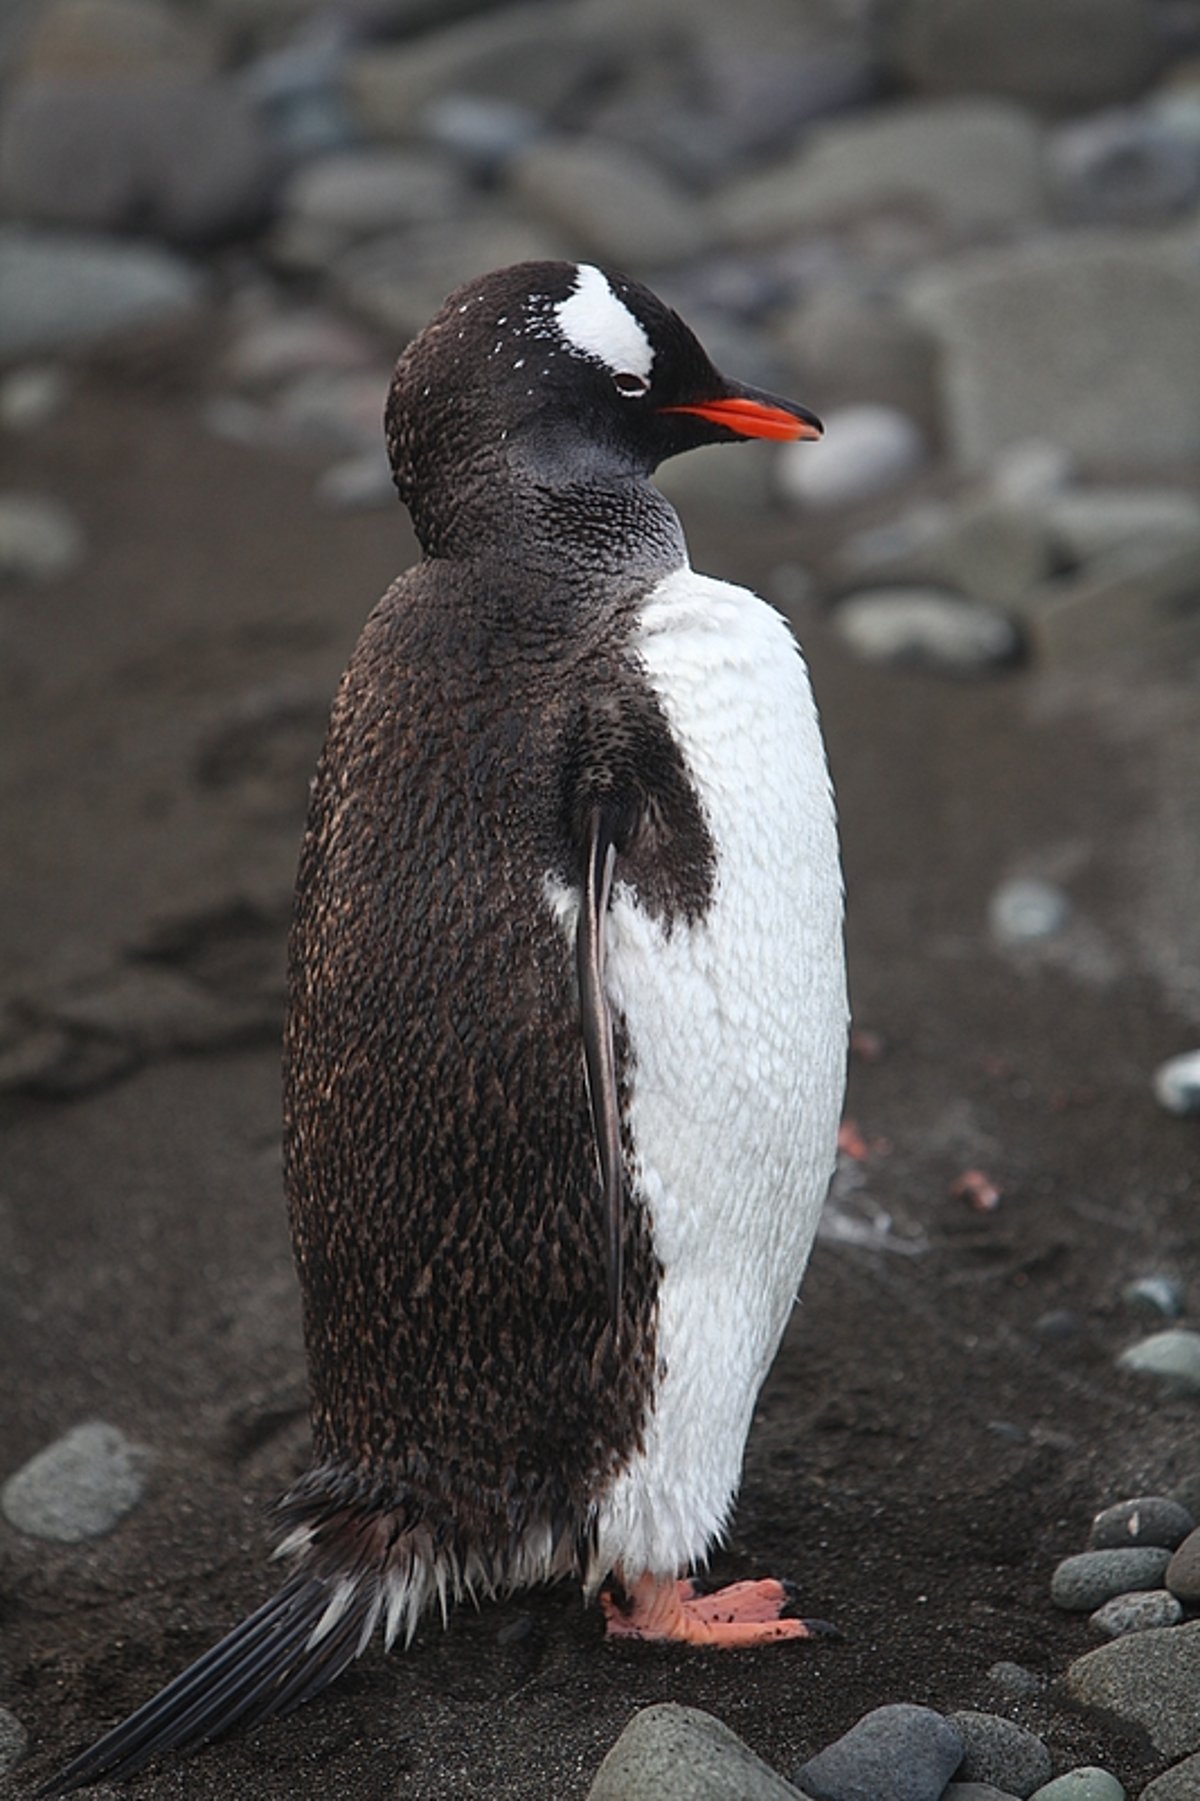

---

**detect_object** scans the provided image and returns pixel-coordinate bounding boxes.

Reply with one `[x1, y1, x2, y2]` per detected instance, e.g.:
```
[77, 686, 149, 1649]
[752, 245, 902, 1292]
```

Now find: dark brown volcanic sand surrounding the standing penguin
[0, 351, 1200, 1801]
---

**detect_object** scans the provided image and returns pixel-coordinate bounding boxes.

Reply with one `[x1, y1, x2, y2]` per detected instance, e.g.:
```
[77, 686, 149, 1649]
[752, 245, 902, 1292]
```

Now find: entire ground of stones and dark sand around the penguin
[0, 0, 1200, 1801]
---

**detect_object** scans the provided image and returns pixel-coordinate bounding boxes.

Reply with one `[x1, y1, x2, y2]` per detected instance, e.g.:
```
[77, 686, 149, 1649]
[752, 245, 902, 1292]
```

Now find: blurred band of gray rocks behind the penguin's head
[0, 0, 1200, 644]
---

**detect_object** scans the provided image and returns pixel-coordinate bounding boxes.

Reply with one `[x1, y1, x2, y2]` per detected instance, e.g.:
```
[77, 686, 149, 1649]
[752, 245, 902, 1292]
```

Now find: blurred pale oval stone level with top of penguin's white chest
[832, 587, 1022, 675]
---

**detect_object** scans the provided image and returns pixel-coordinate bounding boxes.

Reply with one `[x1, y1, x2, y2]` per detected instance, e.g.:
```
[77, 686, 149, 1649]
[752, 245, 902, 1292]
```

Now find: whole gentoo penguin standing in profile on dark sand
[49, 263, 847, 1792]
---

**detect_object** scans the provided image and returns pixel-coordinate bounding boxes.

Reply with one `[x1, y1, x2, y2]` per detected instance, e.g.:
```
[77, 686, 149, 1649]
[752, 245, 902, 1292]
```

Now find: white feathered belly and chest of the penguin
[591, 567, 847, 1581]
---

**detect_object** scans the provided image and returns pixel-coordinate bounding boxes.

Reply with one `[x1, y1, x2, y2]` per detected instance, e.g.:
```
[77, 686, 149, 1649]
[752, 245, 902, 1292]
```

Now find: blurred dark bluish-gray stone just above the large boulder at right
[1047, 112, 1200, 225]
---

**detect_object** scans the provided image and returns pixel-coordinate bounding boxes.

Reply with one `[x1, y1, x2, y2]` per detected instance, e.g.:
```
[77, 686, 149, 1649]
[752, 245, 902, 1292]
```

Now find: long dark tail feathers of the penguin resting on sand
[38, 1572, 380, 1797]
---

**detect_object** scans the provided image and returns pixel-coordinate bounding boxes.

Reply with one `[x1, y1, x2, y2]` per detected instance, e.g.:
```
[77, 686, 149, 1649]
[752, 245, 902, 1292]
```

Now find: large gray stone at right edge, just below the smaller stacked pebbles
[1067, 1619, 1200, 1758]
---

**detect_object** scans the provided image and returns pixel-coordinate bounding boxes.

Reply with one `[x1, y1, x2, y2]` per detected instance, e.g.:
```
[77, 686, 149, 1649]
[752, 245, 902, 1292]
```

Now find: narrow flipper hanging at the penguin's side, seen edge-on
[575, 807, 625, 1329]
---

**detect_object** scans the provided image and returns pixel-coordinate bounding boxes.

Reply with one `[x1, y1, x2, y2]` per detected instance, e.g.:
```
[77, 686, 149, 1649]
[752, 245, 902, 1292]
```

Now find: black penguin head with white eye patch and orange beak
[386, 263, 822, 548]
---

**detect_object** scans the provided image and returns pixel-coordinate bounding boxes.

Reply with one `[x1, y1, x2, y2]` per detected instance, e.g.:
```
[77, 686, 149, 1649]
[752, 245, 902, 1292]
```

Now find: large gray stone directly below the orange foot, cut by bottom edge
[587, 1702, 796, 1801]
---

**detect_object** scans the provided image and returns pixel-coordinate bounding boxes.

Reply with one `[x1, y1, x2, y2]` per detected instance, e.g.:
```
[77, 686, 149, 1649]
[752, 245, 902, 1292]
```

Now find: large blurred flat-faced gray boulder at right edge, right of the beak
[908, 232, 1200, 468]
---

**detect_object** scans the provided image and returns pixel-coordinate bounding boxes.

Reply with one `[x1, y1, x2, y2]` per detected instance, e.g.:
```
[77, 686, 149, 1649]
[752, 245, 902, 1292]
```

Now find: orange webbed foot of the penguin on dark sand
[600, 1576, 834, 1650]
